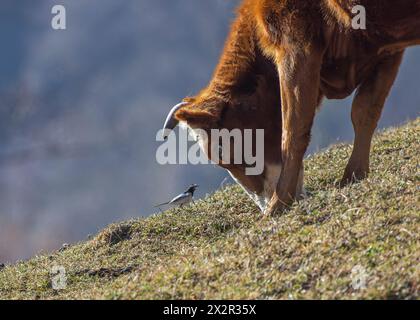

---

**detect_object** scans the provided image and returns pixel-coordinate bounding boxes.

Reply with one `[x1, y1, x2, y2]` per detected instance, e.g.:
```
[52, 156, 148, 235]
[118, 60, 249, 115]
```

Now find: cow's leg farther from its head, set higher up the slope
[340, 52, 403, 186]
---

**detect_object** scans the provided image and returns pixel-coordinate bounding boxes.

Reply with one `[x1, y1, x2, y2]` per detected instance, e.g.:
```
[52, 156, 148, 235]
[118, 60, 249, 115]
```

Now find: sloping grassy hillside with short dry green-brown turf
[0, 120, 420, 299]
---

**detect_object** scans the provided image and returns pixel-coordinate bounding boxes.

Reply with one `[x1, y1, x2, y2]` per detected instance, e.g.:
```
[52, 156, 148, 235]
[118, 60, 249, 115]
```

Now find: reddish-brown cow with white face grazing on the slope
[166, 0, 420, 214]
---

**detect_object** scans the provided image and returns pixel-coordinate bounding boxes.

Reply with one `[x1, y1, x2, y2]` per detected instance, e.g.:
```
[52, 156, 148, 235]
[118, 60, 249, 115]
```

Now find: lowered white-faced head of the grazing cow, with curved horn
[161, 49, 302, 211]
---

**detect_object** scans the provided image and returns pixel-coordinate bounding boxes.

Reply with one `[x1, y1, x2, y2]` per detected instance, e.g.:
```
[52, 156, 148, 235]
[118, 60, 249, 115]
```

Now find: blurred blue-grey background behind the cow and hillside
[0, 0, 420, 263]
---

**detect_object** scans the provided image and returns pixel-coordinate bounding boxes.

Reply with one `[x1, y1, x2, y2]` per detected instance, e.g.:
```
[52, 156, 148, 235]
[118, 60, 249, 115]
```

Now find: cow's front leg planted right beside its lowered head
[266, 47, 322, 215]
